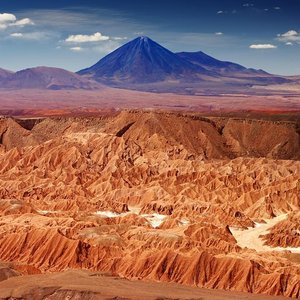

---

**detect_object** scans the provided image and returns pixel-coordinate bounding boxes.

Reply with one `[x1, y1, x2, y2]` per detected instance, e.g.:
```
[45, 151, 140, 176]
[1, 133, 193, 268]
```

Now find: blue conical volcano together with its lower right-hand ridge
[78, 37, 290, 94]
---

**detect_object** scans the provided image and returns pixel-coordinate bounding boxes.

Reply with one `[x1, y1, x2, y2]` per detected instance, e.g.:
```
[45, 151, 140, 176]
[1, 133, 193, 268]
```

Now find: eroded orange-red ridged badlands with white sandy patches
[0, 111, 300, 299]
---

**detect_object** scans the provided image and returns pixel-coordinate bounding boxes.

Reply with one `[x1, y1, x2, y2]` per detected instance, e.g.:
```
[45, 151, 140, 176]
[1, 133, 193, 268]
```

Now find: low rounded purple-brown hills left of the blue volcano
[0, 67, 99, 90]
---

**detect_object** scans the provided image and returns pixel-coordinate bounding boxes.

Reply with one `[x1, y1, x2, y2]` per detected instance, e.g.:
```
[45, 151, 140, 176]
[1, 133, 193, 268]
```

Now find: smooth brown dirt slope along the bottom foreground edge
[0, 270, 287, 300]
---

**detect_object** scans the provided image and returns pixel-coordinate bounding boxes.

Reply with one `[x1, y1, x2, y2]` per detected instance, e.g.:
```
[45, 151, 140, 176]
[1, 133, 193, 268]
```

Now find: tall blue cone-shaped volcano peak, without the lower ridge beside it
[78, 37, 209, 84]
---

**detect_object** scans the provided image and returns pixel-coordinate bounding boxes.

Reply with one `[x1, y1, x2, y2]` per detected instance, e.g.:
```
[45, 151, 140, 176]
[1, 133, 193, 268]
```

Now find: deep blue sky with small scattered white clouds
[0, 0, 300, 75]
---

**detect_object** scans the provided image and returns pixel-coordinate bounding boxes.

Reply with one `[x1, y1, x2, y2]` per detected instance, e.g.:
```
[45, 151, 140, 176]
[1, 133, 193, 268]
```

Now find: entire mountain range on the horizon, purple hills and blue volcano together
[0, 36, 295, 94]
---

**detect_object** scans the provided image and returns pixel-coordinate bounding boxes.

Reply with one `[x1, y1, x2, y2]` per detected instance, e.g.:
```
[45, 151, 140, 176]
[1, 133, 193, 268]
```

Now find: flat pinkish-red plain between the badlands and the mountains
[0, 87, 300, 117]
